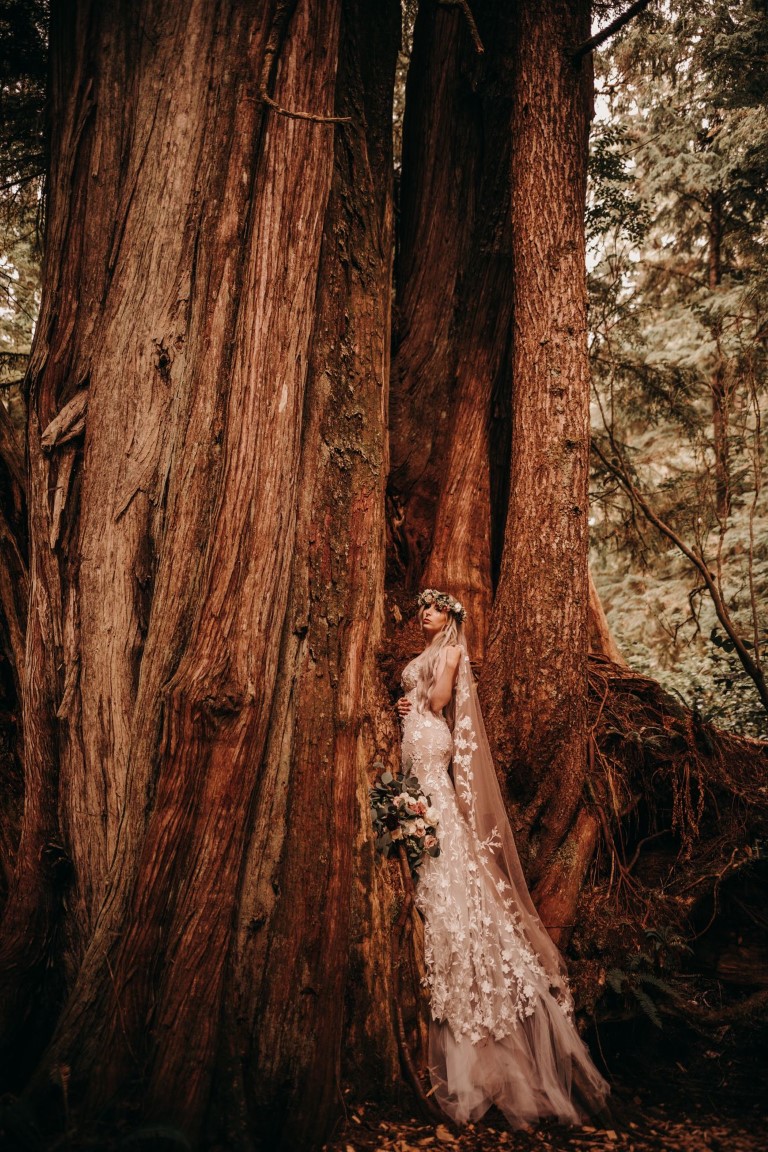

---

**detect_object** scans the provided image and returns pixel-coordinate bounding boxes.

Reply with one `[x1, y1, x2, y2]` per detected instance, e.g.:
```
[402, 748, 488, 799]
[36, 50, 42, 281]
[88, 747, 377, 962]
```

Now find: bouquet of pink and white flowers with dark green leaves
[371, 760, 440, 876]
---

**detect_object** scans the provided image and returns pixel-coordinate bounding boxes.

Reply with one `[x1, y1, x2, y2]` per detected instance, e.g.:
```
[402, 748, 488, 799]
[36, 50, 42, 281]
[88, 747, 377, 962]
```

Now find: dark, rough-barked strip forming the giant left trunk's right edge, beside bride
[226, 0, 400, 1149]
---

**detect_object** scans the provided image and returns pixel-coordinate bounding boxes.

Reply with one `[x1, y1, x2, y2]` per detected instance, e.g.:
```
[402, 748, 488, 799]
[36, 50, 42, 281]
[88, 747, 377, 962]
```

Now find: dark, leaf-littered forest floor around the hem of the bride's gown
[326, 1032, 768, 1152]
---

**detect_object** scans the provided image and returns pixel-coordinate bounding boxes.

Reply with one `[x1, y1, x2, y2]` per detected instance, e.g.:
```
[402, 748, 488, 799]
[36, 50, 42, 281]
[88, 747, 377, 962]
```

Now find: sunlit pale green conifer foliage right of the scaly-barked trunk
[587, 0, 768, 734]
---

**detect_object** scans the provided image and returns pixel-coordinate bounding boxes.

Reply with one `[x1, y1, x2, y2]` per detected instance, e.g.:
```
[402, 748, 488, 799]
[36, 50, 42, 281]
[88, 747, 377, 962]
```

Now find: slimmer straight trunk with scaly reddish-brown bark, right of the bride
[481, 0, 591, 898]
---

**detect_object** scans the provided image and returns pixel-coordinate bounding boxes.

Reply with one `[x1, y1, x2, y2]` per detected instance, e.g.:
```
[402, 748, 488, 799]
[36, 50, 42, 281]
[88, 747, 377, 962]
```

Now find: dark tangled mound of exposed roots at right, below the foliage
[572, 655, 768, 1028]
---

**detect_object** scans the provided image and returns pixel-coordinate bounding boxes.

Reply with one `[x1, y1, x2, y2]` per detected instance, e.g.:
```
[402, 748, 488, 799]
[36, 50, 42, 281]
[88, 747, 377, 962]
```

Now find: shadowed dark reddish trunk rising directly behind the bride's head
[391, 3, 522, 658]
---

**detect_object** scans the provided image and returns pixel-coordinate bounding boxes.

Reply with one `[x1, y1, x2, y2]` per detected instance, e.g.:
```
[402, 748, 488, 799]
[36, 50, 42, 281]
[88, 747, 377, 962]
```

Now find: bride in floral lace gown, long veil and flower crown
[397, 589, 609, 1128]
